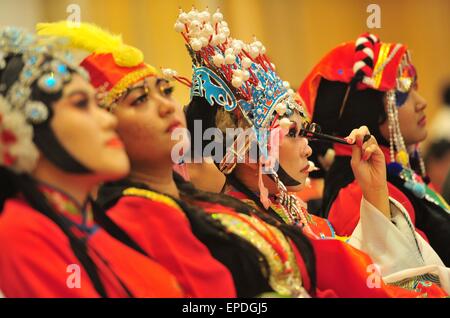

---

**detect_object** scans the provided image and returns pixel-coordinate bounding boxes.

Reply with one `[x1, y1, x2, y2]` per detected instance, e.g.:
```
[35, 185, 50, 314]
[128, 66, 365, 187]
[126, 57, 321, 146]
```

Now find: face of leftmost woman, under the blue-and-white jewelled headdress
[50, 74, 129, 180]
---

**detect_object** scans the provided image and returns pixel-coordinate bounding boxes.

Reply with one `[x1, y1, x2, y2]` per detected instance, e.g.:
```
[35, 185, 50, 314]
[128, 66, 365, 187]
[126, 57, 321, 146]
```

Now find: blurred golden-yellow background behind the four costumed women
[0, 0, 450, 198]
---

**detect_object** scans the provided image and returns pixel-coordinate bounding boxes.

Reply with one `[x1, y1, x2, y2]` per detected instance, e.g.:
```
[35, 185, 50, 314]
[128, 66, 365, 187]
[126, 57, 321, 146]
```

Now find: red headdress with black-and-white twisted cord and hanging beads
[299, 33, 425, 196]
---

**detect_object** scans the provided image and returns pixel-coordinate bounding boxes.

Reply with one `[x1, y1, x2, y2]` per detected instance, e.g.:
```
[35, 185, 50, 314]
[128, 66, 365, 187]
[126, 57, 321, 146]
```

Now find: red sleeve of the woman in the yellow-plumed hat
[108, 196, 236, 297]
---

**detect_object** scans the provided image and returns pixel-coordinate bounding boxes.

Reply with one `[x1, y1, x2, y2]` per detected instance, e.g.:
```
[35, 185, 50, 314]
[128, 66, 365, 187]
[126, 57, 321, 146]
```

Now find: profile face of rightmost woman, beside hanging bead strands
[380, 86, 427, 145]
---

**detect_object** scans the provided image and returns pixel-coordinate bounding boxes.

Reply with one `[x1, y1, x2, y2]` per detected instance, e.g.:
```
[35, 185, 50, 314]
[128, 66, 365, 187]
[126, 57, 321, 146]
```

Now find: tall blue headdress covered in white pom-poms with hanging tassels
[172, 8, 320, 223]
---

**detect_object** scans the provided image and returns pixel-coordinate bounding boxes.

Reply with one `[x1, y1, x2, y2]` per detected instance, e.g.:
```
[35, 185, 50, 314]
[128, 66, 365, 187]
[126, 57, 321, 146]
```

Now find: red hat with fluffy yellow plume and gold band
[36, 21, 157, 109]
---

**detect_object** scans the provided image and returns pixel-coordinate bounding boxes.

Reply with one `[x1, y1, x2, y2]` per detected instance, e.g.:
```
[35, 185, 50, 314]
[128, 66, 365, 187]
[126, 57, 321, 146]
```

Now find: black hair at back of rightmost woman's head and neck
[309, 78, 389, 218]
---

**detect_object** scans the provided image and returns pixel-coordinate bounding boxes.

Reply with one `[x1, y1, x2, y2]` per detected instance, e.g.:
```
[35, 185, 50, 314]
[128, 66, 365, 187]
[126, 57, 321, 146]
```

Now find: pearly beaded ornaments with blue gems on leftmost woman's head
[0, 27, 88, 173]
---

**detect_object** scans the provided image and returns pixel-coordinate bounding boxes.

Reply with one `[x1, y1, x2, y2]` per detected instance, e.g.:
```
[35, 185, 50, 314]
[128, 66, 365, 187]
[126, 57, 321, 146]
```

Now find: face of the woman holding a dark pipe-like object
[279, 113, 312, 191]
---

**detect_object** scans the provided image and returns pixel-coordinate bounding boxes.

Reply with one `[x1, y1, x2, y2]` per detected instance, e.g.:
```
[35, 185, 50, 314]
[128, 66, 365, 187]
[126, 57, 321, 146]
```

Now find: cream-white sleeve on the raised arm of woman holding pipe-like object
[348, 198, 450, 293]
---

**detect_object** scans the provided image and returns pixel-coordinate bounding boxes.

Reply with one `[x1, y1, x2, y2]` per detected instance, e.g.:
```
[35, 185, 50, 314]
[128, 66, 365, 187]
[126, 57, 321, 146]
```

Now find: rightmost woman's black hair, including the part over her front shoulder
[311, 79, 450, 266]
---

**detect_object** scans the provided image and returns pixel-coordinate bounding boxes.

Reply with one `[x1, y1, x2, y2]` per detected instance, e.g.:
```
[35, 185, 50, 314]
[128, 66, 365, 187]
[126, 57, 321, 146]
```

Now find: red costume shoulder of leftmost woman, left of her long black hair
[0, 199, 98, 297]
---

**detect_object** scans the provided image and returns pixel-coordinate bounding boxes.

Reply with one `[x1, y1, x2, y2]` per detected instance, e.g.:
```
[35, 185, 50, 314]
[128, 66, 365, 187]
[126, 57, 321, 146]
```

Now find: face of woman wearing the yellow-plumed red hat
[114, 77, 186, 167]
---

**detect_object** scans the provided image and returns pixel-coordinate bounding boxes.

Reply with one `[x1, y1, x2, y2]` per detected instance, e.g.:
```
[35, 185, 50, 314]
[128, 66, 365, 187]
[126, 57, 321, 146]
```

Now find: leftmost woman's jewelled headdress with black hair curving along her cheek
[0, 27, 89, 173]
